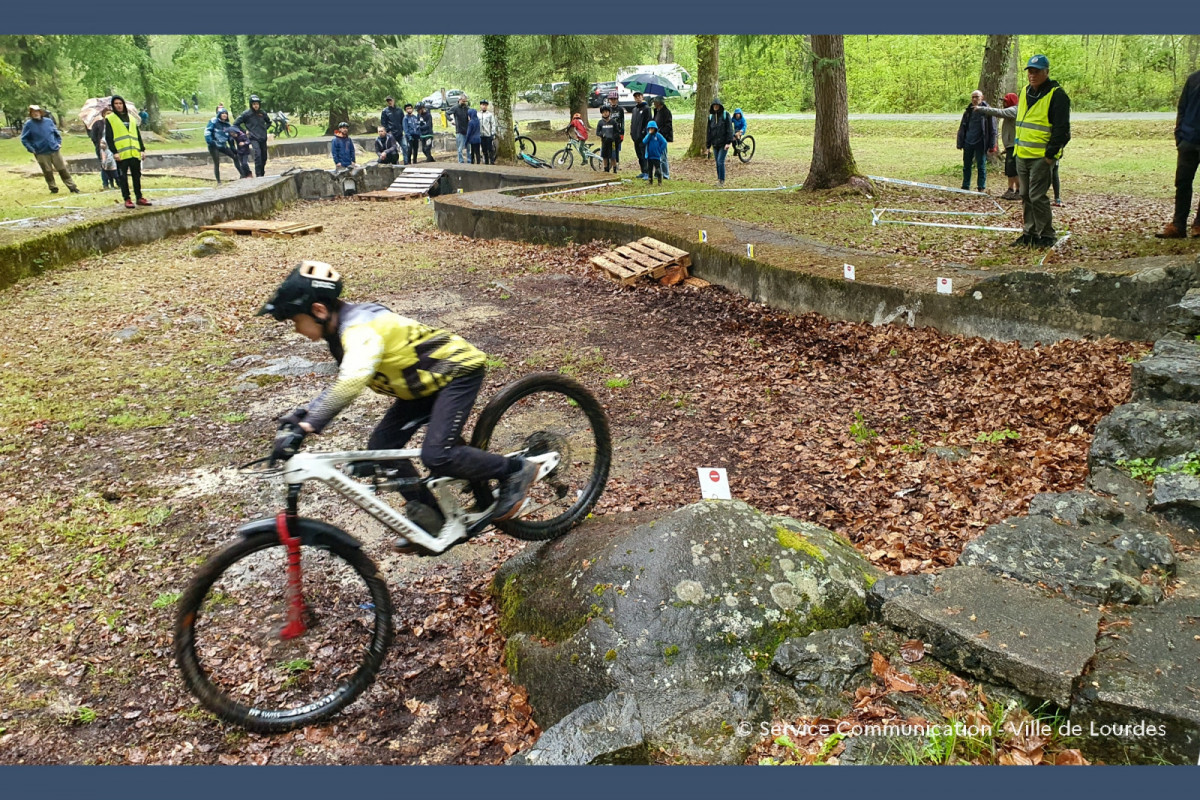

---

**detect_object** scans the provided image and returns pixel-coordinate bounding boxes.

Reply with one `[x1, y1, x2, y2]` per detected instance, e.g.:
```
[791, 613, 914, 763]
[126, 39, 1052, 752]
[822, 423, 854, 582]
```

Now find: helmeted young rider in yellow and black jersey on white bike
[258, 261, 538, 549]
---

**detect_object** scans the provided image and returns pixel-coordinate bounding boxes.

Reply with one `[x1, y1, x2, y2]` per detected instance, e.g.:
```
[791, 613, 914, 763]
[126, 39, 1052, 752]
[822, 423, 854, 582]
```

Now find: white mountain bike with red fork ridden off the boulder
[174, 373, 612, 733]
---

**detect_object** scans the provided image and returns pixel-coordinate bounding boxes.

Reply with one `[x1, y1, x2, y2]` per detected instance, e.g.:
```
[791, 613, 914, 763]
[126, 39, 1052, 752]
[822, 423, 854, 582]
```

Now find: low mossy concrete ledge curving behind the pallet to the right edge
[434, 175, 1200, 343]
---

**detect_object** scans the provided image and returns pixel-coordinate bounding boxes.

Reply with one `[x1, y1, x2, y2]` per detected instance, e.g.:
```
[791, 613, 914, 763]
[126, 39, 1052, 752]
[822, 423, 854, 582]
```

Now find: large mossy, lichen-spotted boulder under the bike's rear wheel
[493, 501, 878, 763]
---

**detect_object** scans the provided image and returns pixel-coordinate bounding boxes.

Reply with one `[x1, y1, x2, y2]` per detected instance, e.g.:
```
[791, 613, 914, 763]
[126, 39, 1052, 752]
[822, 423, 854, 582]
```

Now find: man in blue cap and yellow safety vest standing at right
[1013, 55, 1070, 247]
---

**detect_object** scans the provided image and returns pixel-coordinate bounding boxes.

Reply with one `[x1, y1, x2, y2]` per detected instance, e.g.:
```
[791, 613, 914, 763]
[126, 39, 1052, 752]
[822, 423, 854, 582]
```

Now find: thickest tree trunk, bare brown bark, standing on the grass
[804, 35, 860, 191]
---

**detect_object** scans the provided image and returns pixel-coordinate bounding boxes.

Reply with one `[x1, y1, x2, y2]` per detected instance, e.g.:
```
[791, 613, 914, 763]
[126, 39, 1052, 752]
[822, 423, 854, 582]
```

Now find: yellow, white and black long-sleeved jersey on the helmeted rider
[305, 302, 487, 432]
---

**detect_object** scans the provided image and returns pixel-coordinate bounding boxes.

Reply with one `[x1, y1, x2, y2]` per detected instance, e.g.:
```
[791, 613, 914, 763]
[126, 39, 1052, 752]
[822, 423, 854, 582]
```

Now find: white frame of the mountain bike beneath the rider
[283, 450, 560, 553]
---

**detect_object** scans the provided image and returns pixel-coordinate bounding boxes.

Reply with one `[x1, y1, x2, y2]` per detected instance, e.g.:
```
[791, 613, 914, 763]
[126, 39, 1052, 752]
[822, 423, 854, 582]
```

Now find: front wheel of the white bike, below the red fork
[174, 519, 392, 733]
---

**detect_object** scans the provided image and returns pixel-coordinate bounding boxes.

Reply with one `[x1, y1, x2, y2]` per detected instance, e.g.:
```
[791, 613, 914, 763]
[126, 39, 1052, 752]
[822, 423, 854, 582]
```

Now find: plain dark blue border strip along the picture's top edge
[0, 0, 1200, 35]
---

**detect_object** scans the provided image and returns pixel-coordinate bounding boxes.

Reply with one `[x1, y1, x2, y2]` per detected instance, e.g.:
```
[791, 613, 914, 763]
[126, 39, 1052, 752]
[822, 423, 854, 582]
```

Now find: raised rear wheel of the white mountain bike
[470, 372, 612, 541]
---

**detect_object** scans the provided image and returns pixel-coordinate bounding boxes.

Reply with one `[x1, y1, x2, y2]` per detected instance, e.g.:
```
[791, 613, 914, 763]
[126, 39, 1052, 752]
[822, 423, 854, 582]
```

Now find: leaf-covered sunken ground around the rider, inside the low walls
[0, 196, 1144, 764]
